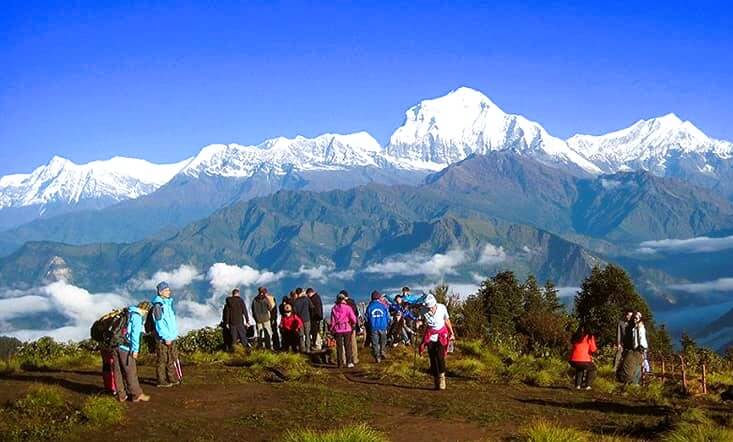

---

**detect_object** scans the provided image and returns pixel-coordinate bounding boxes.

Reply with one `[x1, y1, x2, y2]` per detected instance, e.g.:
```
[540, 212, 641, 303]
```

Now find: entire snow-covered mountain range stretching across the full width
[0, 87, 733, 228]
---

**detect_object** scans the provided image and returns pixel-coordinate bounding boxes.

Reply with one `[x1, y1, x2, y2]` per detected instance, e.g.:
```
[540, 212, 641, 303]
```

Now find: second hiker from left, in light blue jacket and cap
[152, 282, 181, 387]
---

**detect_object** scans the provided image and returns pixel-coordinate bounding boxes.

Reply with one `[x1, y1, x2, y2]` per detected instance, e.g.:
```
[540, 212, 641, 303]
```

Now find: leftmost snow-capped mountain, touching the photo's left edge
[0, 156, 189, 211]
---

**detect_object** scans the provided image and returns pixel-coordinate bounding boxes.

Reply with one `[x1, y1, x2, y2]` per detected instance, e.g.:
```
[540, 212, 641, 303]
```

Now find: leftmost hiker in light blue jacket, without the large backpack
[112, 301, 151, 402]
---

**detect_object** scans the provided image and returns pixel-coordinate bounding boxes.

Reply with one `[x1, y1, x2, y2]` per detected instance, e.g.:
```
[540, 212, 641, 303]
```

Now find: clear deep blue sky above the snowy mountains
[0, 0, 733, 175]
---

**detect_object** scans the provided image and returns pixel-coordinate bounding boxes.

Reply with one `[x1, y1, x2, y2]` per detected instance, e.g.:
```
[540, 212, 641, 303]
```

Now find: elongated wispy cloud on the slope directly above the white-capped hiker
[364, 250, 467, 276]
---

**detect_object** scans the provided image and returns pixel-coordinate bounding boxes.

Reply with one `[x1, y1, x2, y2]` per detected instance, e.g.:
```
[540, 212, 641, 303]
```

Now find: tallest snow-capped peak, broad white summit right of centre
[387, 87, 600, 174]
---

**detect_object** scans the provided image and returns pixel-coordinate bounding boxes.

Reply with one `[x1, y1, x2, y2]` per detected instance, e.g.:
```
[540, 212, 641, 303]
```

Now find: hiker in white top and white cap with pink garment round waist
[420, 295, 455, 390]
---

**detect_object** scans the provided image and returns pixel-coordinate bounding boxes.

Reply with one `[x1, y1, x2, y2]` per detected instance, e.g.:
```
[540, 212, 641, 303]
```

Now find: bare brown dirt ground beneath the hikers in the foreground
[0, 366, 669, 441]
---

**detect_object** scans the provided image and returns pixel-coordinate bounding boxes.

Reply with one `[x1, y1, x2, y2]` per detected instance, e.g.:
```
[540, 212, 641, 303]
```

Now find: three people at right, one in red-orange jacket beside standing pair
[569, 309, 650, 390]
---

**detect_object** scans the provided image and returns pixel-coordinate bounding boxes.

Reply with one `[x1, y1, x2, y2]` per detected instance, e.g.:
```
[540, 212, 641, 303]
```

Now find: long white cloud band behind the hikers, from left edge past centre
[0, 244, 508, 341]
